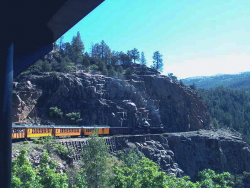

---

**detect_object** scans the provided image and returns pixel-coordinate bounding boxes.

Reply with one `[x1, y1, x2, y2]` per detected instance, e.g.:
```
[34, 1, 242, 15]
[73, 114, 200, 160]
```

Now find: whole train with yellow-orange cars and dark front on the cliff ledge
[12, 125, 163, 140]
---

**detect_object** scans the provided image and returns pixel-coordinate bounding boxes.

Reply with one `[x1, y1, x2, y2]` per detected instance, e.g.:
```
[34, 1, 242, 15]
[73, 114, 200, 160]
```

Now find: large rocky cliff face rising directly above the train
[13, 68, 210, 131]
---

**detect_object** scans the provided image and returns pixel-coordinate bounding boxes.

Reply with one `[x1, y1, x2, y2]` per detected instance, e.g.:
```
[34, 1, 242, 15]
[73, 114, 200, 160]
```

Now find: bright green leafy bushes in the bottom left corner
[12, 150, 68, 188]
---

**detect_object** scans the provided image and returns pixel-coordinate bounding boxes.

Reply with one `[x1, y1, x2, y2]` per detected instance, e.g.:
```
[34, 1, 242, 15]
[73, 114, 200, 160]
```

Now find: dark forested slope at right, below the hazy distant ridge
[198, 87, 250, 143]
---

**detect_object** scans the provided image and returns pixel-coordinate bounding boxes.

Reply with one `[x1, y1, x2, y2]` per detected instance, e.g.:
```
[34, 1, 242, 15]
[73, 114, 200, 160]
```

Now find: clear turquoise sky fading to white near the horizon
[60, 0, 250, 79]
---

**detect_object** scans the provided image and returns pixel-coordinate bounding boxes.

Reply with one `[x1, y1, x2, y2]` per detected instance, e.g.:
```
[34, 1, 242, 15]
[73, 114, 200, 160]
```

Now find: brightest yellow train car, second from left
[26, 125, 53, 138]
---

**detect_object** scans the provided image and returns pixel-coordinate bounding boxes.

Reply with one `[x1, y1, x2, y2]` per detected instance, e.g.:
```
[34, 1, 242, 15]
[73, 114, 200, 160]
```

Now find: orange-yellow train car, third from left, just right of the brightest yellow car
[53, 126, 81, 136]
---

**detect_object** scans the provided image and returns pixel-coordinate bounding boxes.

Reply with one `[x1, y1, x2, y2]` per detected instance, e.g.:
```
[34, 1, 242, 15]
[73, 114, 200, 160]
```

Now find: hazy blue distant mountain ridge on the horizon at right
[182, 71, 250, 90]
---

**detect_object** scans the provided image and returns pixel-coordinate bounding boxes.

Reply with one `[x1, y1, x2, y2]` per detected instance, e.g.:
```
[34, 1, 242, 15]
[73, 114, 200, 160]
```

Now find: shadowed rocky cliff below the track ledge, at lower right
[114, 130, 250, 179]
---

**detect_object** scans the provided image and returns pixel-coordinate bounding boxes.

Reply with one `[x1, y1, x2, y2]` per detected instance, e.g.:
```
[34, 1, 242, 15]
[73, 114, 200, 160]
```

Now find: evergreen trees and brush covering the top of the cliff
[23, 32, 163, 78]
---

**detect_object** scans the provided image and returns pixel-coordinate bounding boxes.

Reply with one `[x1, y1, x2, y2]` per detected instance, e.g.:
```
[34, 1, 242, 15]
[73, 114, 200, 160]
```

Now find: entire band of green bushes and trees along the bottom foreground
[12, 133, 246, 188]
